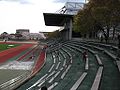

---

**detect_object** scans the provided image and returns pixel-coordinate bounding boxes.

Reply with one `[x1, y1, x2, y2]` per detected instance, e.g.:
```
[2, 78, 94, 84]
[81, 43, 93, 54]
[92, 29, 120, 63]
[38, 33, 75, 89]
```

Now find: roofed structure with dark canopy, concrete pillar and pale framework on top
[43, 2, 84, 40]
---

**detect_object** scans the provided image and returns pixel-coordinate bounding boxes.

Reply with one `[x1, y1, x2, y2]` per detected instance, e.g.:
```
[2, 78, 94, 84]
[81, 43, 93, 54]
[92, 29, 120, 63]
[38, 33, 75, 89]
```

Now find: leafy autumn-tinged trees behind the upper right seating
[73, 0, 120, 42]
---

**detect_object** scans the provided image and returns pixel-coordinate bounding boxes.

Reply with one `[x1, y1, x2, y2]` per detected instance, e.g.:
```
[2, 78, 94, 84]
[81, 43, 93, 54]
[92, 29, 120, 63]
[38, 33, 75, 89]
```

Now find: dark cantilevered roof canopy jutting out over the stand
[43, 13, 73, 26]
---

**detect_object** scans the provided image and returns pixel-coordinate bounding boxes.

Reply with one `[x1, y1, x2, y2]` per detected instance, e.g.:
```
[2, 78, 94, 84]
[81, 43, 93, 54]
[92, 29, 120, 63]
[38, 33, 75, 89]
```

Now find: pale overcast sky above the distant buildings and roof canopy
[0, 0, 84, 33]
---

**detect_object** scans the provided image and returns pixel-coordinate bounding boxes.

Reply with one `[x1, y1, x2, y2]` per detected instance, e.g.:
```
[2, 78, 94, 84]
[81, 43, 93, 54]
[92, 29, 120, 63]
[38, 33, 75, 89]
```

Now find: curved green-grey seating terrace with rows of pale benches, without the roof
[17, 41, 120, 90]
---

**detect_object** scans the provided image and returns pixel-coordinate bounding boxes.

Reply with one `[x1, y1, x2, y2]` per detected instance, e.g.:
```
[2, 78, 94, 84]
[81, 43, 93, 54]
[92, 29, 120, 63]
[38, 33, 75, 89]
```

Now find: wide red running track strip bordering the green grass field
[0, 44, 33, 63]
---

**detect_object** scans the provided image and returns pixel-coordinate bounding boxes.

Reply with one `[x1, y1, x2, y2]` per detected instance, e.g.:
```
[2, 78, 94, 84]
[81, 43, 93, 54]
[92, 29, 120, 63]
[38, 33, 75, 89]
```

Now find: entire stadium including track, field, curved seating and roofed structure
[0, 2, 120, 90]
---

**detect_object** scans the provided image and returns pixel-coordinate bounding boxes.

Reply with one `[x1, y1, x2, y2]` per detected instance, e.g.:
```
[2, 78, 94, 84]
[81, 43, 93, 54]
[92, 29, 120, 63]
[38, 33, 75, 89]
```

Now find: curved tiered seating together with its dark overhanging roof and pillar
[8, 0, 120, 90]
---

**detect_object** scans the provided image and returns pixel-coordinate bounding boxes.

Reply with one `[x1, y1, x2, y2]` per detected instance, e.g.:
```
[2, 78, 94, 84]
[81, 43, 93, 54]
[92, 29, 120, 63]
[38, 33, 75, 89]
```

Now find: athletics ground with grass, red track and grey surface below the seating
[0, 42, 41, 90]
